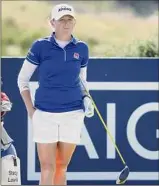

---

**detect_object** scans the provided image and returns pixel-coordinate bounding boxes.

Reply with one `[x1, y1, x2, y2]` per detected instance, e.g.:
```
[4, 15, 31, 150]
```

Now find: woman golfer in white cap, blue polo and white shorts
[18, 4, 94, 185]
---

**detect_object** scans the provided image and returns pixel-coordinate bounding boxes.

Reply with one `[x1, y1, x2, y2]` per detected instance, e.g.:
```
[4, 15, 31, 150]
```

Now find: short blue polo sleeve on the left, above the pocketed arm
[26, 41, 40, 65]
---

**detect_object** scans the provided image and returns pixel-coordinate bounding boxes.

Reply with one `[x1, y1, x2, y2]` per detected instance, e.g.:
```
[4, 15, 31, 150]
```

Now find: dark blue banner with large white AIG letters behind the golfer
[1, 58, 159, 185]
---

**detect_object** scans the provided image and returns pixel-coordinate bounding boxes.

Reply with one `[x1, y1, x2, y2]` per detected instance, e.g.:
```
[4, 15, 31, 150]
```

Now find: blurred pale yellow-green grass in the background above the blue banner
[2, 1, 158, 57]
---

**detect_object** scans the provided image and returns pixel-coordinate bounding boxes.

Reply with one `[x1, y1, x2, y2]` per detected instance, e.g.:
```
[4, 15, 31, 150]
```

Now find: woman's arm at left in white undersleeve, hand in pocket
[17, 59, 37, 118]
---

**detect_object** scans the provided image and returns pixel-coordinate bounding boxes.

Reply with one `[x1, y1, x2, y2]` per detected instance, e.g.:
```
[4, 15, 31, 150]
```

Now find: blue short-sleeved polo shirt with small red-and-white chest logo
[26, 33, 89, 112]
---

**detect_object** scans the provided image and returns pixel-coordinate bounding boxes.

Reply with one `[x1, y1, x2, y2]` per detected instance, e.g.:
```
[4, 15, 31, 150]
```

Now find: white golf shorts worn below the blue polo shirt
[32, 109, 84, 144]
